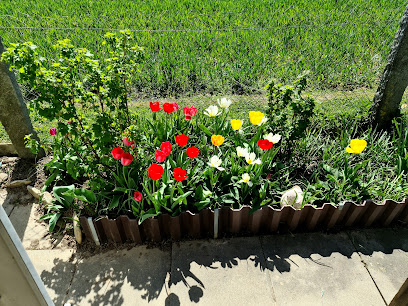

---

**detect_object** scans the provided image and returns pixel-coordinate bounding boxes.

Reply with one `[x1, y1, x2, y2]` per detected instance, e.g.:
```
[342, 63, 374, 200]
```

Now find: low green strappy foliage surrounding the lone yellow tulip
[292, 118, 408, 204]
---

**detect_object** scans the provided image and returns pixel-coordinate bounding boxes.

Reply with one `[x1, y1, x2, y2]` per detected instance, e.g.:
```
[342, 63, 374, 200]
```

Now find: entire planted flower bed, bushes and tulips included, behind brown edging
[2, 31, 408, 229]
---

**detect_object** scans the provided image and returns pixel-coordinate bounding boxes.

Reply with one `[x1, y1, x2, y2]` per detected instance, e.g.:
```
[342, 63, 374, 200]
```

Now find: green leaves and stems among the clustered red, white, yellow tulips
[127, 106, 278, 222]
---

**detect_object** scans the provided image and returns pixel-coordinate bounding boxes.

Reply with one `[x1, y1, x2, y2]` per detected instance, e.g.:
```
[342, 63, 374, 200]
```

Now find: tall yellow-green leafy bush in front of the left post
[2, 30, 143, 180]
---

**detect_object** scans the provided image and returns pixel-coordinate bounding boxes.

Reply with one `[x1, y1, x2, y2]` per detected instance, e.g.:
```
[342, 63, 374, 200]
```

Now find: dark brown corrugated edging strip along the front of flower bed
[80, 198, 408, 244]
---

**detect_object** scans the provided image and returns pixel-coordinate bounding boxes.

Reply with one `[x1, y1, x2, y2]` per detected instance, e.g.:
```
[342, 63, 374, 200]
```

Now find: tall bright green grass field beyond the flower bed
[0, 0, 406, 98]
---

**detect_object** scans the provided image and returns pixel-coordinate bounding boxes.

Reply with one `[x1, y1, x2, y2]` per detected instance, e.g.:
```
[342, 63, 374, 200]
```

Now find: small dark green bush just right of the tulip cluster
[266, 74, 315, 142]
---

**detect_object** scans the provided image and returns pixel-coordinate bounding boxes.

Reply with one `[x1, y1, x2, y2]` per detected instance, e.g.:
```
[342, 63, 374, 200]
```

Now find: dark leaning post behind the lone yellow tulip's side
[371, 6, 408, 129]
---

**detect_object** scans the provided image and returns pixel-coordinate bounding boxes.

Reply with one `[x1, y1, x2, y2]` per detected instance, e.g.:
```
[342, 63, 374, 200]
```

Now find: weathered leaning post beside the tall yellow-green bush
[0, 39, 44, 158]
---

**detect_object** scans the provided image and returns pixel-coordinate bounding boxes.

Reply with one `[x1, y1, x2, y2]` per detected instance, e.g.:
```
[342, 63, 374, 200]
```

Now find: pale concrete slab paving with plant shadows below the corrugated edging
[0, 194, 408, 306]
